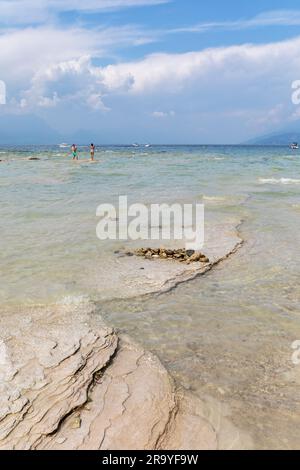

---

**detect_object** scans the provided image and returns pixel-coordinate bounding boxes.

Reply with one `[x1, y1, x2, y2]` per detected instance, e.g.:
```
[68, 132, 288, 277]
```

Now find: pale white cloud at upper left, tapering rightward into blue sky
[0, 26, 153, 86]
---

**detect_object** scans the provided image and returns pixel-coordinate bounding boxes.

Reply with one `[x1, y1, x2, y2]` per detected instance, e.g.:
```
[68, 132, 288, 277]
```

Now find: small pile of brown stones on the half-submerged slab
[134, 248, 209, 264]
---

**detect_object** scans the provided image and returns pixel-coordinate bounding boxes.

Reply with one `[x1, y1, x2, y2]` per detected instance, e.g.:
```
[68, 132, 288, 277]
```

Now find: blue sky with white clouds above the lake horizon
[0, 0, 300, 144]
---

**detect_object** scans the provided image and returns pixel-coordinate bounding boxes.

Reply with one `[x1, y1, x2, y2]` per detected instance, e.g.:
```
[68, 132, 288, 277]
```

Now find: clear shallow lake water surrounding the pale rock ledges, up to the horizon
[0, 146, 300, 448]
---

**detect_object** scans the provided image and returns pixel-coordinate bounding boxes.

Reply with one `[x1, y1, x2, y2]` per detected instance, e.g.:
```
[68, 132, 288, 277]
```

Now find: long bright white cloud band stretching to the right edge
[95, 37, 300, 94]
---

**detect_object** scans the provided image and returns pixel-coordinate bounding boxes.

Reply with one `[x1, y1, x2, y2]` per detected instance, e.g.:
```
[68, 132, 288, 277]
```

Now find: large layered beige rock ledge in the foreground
[0, 302, 250, 450]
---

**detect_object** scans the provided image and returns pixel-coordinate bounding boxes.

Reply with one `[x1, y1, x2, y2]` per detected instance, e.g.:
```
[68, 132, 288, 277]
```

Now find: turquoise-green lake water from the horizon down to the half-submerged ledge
[0, 143, 300, 303]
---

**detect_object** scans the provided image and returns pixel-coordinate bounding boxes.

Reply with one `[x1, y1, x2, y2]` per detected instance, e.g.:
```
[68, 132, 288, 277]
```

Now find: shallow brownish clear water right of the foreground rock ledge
[99, 211, 300, 449]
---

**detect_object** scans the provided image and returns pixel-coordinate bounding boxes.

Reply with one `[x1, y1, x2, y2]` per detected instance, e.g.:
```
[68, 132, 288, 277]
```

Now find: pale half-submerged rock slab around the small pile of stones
[88, 218, 243, 300]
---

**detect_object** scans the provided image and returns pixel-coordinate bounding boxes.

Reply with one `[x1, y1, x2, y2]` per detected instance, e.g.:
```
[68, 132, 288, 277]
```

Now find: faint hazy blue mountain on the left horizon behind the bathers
[0, 114, 62, 145]
